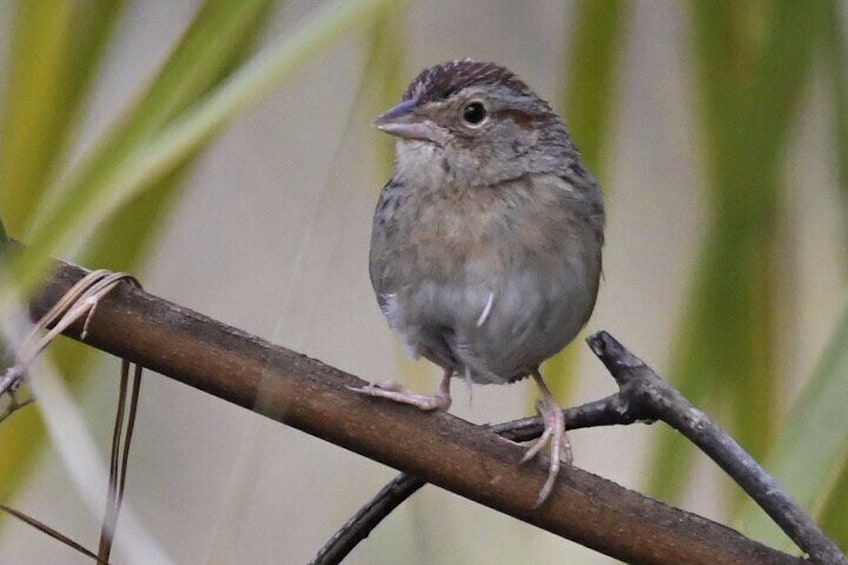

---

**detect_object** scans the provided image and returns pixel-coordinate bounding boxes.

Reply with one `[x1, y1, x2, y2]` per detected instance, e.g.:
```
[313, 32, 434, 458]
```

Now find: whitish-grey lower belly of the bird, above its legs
[387, 259, 597, 384]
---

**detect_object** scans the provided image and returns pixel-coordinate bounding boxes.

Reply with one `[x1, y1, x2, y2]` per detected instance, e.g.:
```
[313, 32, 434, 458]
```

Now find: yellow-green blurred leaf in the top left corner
[0, 0, 126, 234]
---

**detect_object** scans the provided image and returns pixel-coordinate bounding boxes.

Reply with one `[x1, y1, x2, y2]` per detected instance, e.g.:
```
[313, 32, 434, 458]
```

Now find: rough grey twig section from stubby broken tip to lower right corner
[587, 331, 848, 565]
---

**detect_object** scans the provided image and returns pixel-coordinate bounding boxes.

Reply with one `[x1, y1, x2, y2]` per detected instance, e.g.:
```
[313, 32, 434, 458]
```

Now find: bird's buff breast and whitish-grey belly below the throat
[371, 172, 603, 383]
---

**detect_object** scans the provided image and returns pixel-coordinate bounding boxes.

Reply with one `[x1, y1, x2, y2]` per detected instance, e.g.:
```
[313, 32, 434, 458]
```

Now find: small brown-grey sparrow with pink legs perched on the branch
[355, 59, 604, 504]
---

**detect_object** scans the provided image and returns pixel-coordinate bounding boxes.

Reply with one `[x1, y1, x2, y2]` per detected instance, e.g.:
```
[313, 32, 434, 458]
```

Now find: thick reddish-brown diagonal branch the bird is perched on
[31, 265, 803, 564]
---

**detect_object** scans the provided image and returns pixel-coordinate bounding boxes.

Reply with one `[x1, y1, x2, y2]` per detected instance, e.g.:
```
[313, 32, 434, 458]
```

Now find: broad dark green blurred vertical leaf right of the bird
[651, 1, 823, 499]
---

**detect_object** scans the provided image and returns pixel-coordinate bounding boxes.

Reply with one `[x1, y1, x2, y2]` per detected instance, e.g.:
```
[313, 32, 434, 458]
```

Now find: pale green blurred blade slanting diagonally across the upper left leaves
[0, 0, 399, 310]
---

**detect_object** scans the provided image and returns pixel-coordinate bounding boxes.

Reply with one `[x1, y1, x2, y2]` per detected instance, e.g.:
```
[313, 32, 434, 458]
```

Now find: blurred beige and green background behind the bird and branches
[0, 0, 848, 564]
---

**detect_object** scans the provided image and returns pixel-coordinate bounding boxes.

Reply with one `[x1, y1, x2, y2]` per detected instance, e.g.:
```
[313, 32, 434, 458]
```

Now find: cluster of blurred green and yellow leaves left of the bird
[0, 0, 400, 508]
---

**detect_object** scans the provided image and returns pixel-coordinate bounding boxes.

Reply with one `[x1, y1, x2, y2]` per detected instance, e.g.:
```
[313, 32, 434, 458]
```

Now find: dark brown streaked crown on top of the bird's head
[403, 59, 532, 103]
